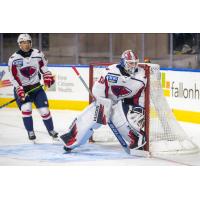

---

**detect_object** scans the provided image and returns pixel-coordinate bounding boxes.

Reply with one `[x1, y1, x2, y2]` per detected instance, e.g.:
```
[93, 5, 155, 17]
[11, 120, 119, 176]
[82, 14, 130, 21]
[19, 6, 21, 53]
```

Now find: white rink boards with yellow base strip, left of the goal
[0, 65, 89, 110]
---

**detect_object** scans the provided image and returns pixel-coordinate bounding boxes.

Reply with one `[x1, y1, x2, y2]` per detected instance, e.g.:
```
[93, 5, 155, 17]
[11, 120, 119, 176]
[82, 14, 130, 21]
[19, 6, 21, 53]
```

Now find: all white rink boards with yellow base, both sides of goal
[0, 64, 200, 124]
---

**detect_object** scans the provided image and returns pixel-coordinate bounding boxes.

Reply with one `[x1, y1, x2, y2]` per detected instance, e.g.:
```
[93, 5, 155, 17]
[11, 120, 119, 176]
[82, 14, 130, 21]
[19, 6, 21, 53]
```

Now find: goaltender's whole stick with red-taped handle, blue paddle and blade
[72, 66, 149, 157]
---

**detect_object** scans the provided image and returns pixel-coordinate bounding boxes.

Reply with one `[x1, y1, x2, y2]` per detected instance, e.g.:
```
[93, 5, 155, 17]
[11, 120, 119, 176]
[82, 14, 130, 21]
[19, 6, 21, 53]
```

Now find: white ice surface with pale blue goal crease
[0, 108, 200, 166]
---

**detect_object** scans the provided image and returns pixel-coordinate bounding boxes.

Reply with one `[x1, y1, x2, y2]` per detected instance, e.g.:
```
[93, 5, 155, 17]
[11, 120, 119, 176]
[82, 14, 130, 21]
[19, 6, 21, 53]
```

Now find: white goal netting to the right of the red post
[149, 64, 199, 154]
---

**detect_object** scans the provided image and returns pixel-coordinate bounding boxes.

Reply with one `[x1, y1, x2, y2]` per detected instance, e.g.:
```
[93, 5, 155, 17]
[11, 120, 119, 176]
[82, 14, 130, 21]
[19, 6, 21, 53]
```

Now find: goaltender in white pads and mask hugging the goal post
[60, 50, 147, 151]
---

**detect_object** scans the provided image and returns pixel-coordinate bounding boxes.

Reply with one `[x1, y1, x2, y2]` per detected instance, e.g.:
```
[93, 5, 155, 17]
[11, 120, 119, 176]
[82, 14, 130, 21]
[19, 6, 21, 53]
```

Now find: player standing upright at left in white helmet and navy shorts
[8, 34, 58, 140]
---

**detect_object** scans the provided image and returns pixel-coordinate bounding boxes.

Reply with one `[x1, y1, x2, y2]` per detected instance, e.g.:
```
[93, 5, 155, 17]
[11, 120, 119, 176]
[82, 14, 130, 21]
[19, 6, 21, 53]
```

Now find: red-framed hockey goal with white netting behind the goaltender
[89, 62, 199, 155]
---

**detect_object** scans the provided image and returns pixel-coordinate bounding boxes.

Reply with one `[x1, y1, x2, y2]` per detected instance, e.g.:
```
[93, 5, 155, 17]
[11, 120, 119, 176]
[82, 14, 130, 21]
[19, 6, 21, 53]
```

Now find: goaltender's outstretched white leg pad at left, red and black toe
[60, 103, 99, 149]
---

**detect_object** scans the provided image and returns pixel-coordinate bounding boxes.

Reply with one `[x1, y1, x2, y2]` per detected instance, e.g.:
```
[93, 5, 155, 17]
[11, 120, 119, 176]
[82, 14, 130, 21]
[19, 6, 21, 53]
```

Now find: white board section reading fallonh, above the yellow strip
[161, 70, 200, 112]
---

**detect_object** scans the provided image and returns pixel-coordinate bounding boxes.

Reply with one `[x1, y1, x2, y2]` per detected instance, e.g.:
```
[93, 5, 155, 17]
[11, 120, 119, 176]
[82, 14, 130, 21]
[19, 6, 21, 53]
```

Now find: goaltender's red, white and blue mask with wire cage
[120, 50, 139, 74]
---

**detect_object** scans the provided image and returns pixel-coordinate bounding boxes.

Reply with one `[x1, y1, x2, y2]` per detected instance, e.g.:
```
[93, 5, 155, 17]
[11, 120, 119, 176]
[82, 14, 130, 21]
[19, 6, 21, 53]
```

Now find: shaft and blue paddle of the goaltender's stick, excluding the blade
[72, 66, 133, 154]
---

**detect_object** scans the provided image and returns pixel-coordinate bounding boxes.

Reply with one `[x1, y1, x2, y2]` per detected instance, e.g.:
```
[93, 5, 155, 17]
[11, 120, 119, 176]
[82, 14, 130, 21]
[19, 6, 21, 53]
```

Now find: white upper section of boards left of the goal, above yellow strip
[0, 66, 89, 101]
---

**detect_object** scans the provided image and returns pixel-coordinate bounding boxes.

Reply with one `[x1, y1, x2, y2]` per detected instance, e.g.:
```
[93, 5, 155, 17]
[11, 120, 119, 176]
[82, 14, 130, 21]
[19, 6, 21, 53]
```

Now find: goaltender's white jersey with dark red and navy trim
[93, 64, 147, 106]
